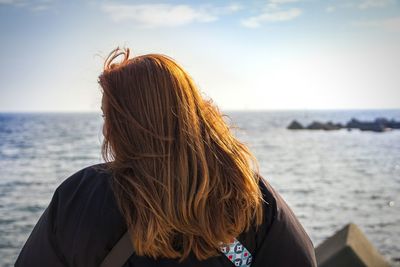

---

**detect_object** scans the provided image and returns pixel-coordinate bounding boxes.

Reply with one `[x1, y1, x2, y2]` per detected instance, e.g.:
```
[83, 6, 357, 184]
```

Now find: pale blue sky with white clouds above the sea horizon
[0, 0, 400, 112]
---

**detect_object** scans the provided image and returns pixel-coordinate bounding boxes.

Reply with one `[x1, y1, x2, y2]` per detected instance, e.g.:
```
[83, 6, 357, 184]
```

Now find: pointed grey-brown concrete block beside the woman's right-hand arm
[315, 223, 389, 267]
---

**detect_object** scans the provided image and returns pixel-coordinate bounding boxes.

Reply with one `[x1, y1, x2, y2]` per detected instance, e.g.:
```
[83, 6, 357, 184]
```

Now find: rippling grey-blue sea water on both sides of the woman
[0, 110, 400, 266]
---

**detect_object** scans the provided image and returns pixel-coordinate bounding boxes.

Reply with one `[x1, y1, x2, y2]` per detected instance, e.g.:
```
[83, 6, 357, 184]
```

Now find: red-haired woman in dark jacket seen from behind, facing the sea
[16, 48, 316, 267]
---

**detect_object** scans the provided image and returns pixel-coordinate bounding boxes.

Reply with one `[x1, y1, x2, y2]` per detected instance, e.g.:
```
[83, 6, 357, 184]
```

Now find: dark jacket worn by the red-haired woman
[15, 164, 316, 267]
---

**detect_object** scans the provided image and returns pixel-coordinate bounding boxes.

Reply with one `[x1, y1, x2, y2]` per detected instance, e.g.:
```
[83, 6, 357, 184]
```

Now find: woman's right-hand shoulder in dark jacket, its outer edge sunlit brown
[254, 175, 316, 267]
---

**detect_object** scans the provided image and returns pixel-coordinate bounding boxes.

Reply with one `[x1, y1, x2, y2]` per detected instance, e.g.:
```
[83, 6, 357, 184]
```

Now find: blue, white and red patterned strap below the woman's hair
[221, 238, 253, 267]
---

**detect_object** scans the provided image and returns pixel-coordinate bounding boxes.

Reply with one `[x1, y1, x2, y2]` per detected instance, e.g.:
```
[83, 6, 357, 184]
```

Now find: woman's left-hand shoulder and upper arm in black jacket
[16, 164, 126, 266]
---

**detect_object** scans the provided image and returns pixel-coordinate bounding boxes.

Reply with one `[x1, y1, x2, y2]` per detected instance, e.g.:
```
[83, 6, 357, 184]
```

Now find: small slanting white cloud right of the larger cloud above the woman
[241, 8, 302, 28]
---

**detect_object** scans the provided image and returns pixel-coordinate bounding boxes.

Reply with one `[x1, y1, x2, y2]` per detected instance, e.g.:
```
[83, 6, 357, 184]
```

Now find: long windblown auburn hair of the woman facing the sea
[99, 48, 263, 262]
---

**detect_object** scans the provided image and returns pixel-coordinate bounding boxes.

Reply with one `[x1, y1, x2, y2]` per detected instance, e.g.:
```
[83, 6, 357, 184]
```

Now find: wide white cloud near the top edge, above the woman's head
[101, 4, 241, 28]
